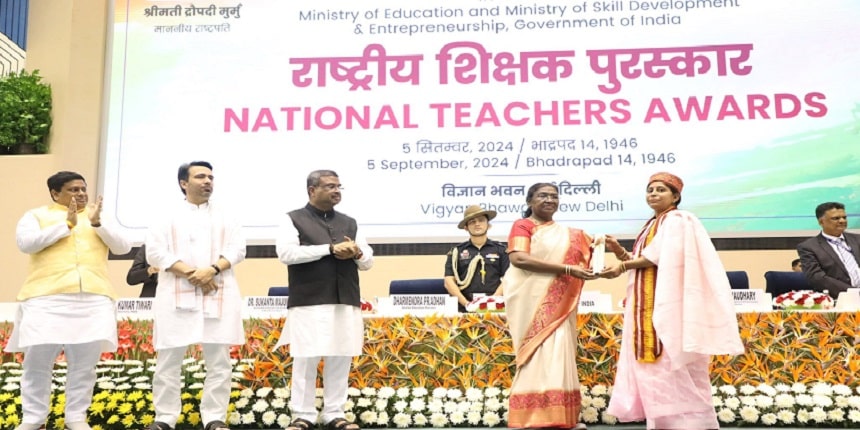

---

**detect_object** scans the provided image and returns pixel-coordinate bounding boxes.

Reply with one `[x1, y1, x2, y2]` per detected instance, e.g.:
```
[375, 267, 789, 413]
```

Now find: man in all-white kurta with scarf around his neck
[146, 161, 245, 430]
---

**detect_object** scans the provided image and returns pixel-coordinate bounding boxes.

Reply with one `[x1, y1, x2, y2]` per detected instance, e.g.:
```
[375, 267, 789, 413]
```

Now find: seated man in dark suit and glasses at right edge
[797, 202, 860, 298]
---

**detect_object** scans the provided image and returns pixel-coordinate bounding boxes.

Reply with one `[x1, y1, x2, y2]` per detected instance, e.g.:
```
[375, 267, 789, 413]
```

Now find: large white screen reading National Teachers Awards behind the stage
[100, 0, 860, 244]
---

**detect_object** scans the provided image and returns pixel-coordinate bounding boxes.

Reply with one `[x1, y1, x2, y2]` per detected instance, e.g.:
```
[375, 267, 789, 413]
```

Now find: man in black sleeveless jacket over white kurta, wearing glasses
[276, 170, 373, 430]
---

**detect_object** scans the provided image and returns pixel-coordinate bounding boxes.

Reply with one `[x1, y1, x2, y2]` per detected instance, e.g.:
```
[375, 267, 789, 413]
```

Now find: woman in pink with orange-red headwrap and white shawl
[600, 172, 744, 430]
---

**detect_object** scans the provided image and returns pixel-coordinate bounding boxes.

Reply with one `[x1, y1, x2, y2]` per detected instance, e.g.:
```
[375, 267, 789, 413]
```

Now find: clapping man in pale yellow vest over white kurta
[4, 172, 131, 430]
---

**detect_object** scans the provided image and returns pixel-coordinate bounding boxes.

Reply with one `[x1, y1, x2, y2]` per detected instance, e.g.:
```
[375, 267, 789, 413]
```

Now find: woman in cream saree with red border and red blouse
[503, 183, 597, 429]
